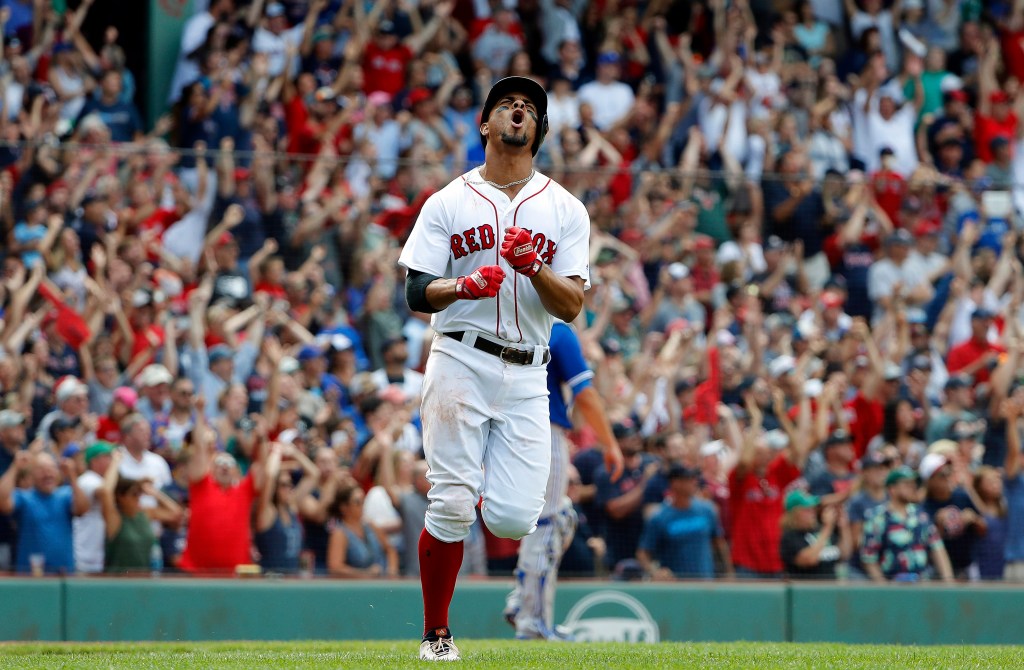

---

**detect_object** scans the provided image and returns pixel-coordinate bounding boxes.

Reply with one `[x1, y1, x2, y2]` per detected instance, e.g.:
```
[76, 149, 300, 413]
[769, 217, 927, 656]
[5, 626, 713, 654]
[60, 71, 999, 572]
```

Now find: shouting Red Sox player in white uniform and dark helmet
[398, 77, 590, 661]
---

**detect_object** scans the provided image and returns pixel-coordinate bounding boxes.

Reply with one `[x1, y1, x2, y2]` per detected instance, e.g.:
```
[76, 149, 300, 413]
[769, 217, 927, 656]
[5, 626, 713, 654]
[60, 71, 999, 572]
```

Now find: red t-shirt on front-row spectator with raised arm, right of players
[729, 454, 801, 573]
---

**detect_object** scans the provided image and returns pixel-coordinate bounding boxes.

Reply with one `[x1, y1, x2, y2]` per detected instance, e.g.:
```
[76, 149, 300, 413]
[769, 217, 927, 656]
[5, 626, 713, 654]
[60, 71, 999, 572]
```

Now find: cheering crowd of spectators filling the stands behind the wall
[0, 0, 1024, 582]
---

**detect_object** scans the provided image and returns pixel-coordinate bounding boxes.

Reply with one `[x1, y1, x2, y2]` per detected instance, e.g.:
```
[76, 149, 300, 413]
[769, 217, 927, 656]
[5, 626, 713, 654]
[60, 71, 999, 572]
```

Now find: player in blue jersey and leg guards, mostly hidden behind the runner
[504, 322, 623, 641]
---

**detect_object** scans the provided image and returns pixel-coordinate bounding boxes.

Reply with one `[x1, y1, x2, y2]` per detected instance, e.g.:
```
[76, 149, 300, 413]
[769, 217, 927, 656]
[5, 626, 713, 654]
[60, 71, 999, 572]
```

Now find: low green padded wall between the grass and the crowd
[6, 578, 1024, 644]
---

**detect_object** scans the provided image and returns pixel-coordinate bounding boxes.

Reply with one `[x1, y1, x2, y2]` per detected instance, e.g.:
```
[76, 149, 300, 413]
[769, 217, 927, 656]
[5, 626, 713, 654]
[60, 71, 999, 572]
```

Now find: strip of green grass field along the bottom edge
[0, 639, 1024, 670]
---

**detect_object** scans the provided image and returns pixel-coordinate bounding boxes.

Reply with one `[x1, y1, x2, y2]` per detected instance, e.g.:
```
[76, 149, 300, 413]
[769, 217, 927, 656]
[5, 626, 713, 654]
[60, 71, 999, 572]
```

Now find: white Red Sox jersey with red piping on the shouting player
[398, 169, 590, 345]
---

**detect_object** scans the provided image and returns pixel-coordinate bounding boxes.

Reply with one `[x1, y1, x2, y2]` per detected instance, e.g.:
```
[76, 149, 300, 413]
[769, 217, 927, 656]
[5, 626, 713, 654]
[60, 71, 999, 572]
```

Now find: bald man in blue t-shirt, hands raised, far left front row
[0, 451, 89, 574]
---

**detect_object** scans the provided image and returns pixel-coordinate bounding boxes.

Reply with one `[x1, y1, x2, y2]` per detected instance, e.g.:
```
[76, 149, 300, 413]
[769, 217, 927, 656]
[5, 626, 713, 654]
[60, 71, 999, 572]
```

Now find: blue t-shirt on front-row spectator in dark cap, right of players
[639, 498, 722, 579]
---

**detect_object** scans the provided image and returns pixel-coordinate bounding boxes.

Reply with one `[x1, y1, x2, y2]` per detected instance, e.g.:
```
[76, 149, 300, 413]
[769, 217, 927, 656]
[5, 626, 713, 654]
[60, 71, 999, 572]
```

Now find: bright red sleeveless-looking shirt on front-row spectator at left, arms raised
[181, 474, 256, 573]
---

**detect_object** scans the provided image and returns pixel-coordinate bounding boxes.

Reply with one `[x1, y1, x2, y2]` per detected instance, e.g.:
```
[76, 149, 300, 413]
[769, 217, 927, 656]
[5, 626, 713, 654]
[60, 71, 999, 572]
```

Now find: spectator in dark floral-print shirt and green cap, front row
[860, 466, 953, 582]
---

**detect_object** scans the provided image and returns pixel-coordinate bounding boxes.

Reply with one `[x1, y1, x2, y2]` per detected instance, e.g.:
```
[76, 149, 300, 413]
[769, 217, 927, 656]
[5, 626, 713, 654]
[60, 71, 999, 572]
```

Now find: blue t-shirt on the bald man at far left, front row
[14, 486, 75, 574]
